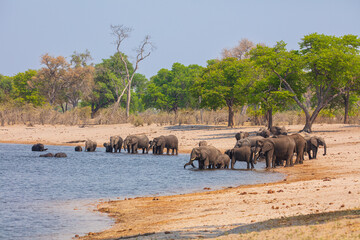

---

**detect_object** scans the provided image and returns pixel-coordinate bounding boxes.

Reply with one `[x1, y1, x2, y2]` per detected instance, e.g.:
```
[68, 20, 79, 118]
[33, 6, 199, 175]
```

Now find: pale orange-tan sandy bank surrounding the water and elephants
[0, 124, 360, 239]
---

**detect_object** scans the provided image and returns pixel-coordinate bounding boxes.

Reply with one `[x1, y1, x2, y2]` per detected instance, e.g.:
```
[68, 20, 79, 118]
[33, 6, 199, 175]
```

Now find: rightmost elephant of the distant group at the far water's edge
[150, 135, 179, 155]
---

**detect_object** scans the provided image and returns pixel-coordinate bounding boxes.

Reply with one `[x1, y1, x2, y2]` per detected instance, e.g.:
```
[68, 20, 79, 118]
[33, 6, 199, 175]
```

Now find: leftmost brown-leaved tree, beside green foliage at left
[31, 54, 69, 105]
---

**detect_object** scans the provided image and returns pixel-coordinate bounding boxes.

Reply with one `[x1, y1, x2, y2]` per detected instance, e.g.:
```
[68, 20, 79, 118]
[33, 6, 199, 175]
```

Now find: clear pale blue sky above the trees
[0, 0, 360, 78]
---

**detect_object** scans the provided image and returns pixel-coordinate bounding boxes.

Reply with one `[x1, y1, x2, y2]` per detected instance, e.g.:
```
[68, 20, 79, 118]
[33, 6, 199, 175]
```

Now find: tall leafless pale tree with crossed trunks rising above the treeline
[110, 25, 154, 117]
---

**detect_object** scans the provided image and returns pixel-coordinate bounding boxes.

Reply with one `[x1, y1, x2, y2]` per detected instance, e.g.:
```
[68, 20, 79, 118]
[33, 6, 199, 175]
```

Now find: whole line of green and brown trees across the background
[0, 32, 360, 132]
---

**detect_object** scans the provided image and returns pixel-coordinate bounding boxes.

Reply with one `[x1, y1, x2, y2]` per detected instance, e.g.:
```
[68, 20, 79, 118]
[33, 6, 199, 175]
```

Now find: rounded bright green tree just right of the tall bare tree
[144, 63, 202, 114]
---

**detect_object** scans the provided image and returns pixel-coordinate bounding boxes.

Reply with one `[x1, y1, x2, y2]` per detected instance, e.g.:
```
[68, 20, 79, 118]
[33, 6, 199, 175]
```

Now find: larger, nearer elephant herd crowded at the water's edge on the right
[184, 127, 326, 169]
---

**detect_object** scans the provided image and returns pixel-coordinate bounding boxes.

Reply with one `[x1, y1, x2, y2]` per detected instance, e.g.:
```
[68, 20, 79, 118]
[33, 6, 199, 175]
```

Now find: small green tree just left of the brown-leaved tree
[12, 70, 44, 106]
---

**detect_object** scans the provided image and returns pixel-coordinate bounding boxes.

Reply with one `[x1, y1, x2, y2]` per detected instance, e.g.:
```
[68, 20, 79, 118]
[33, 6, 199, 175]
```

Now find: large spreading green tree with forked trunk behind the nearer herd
[250, 33, 359, 132]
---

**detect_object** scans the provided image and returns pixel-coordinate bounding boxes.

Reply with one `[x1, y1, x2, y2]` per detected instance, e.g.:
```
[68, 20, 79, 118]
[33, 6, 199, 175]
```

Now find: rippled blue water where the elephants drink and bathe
[0, 144, 283, 240]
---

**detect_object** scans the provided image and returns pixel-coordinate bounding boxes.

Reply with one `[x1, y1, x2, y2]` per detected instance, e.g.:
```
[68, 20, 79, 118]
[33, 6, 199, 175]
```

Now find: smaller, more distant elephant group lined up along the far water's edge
[75, 134, 179, 155]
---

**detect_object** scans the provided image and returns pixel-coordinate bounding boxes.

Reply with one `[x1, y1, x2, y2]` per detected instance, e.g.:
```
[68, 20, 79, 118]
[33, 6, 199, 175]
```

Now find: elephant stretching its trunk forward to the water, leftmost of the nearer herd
[184, 146, 222, 169]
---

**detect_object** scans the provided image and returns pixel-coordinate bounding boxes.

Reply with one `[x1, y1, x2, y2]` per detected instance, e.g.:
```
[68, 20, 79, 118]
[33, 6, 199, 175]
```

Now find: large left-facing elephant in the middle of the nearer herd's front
[256, 136, 296, 169]
